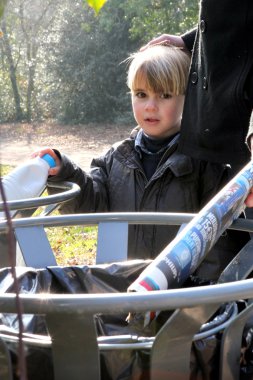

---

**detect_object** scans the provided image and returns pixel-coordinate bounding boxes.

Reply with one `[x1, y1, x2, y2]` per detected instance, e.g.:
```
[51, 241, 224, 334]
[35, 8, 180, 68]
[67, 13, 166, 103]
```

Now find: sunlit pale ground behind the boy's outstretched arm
[0, 123, 132, 169]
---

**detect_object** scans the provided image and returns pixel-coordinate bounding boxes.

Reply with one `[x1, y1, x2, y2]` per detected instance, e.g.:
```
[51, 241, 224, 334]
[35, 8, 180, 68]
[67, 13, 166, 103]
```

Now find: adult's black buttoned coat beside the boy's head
[179, 0, 253, 165]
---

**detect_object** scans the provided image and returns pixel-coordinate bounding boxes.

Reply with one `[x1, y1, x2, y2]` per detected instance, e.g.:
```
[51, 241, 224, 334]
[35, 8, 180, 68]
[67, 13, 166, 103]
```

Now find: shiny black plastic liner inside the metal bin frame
[0, 260, 252, 380]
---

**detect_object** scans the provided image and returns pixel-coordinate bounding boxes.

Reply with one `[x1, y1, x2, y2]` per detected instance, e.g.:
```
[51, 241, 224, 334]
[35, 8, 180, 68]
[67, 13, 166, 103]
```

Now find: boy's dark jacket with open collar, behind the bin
[50, 132, 248, 279]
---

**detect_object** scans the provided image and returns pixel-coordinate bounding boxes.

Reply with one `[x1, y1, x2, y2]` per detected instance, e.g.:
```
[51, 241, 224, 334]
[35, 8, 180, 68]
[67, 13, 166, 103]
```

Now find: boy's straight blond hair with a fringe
[127, 45, 190, 95]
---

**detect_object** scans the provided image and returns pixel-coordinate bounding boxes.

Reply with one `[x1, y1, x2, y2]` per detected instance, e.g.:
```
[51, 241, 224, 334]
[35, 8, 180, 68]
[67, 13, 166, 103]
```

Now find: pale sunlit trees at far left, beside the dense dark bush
[0, 0, 60, 121]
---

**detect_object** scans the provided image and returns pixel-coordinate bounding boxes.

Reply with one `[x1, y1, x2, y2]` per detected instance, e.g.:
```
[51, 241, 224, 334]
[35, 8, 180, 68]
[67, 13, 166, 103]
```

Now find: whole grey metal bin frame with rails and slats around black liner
[0, 183, 253, 380]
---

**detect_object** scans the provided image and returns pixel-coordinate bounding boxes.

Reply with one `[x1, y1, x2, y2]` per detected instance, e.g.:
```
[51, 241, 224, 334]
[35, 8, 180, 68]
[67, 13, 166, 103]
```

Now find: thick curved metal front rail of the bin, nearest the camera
[0, 279, 253, 314]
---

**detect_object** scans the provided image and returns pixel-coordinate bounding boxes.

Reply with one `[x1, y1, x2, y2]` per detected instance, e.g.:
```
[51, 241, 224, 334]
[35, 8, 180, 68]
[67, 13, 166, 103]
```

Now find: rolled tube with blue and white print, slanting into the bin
[128, 161, 253, 324]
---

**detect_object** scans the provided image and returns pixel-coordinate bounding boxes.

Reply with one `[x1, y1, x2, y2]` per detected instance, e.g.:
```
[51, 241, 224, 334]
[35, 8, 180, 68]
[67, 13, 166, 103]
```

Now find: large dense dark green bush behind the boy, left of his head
[49, 0, 139, 123]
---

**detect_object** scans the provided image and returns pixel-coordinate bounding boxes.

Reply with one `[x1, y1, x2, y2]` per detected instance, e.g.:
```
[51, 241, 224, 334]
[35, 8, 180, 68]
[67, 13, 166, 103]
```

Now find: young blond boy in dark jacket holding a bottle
[34, 45, 247, 279]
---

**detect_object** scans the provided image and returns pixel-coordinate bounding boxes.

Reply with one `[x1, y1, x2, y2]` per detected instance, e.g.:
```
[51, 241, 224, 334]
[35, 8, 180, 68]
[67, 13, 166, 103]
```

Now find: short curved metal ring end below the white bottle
[0, 181, 80, 211]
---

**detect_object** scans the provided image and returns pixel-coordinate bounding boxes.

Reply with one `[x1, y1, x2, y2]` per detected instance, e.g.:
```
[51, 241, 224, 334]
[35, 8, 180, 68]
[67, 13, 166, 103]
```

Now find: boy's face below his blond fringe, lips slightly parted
[132, 80, 184, 139]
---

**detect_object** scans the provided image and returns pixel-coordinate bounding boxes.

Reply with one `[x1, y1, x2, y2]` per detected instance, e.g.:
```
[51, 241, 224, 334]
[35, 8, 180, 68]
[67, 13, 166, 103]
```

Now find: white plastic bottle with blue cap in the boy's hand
[0, 154, 55, 218]
